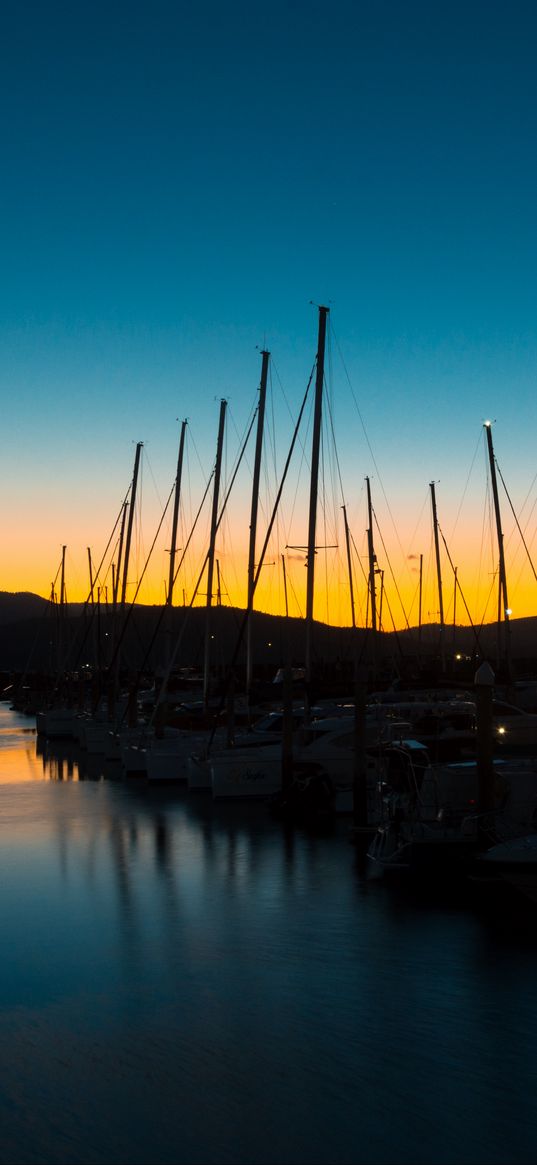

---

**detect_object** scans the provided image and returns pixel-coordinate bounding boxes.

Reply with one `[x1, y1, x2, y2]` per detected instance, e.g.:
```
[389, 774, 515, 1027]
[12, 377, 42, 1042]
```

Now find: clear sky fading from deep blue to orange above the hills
[0, 0, 537, 629]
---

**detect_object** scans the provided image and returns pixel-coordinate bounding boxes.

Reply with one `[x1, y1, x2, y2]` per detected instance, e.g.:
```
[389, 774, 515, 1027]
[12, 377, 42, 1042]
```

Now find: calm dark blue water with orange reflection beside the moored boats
[0, 704, 537, 1165]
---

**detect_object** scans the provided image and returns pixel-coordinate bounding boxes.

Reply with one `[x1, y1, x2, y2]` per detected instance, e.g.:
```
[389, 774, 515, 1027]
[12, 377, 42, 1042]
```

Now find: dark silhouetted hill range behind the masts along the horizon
[0, 592, 537, 685]
